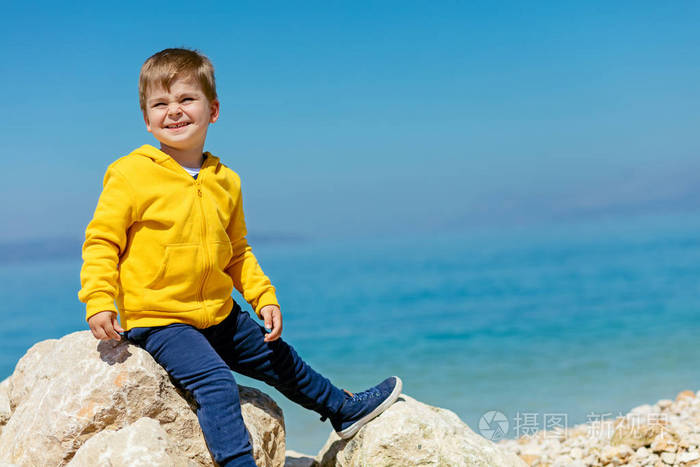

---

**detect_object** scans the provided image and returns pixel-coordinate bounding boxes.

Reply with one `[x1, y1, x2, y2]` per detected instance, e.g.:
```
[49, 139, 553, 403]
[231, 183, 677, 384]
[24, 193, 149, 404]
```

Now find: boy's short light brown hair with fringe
[139, 49, 216, 112]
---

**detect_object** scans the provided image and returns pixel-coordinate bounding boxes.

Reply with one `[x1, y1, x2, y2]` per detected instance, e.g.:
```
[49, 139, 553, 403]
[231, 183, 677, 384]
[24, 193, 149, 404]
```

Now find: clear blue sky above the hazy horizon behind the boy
[0, 1, 700, 241]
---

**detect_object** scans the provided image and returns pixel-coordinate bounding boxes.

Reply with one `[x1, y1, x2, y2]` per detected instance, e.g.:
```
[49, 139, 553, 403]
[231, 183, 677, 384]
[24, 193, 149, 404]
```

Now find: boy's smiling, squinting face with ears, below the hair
[143, 77, 219, 152]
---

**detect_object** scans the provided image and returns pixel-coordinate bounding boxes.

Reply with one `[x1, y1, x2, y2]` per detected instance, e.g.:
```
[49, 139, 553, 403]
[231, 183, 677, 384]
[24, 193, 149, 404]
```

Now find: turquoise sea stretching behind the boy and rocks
[0, 213, 700, 454]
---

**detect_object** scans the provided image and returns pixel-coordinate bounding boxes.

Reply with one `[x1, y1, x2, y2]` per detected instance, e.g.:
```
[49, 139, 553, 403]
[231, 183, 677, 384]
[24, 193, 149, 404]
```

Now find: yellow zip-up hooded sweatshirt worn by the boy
[78, 145, 277, 330]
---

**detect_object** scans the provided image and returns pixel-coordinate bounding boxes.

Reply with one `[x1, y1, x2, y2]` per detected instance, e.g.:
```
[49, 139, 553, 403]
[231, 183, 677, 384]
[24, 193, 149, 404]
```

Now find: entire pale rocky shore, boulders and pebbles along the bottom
[6, 331, 672, 467]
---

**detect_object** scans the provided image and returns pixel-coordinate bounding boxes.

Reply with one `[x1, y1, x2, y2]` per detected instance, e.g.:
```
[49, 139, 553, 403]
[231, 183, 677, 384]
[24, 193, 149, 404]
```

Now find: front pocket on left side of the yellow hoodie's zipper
[144, 243, 203, 310]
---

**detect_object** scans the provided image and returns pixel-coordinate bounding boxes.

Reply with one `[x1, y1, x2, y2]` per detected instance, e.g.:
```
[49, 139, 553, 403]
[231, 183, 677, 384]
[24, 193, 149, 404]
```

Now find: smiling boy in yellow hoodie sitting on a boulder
[78, 49, 401, 467]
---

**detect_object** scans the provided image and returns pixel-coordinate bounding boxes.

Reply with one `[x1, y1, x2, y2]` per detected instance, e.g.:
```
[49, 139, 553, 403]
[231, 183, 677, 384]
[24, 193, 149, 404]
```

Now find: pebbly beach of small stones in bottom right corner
[499, 391, 700, 467]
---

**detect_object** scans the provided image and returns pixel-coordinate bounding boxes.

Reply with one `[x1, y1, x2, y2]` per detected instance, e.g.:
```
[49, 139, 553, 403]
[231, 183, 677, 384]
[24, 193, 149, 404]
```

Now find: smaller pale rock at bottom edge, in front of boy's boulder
[68, 417, 198, 467]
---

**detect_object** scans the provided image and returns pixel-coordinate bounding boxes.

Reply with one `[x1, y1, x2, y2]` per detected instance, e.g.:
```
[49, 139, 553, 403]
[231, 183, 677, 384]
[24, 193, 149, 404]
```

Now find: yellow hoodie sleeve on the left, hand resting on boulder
[78, 166, 135, 320]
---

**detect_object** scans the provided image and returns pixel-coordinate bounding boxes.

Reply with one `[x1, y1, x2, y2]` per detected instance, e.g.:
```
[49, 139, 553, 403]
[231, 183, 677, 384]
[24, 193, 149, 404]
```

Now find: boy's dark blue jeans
[125, 302, 345, 467]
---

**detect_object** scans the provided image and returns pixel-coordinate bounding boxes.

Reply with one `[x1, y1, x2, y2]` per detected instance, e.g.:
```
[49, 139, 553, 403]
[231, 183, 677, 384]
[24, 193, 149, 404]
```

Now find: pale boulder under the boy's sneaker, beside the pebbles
[316, 394, 526, 467]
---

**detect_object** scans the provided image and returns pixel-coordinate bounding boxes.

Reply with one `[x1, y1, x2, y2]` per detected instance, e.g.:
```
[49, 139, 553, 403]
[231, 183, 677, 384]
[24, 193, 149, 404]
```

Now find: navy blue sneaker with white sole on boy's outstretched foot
[329, 376, 402, 439]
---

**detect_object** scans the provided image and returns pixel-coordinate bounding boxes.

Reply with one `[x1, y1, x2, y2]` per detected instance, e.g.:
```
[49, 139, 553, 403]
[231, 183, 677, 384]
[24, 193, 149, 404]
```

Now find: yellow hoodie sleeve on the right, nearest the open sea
[226, 175, 279, 318]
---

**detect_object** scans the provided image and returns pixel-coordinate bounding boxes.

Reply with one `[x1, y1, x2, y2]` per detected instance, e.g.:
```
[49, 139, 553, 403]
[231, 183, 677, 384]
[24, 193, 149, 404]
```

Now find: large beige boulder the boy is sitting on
[0, 331, 285, 466]
